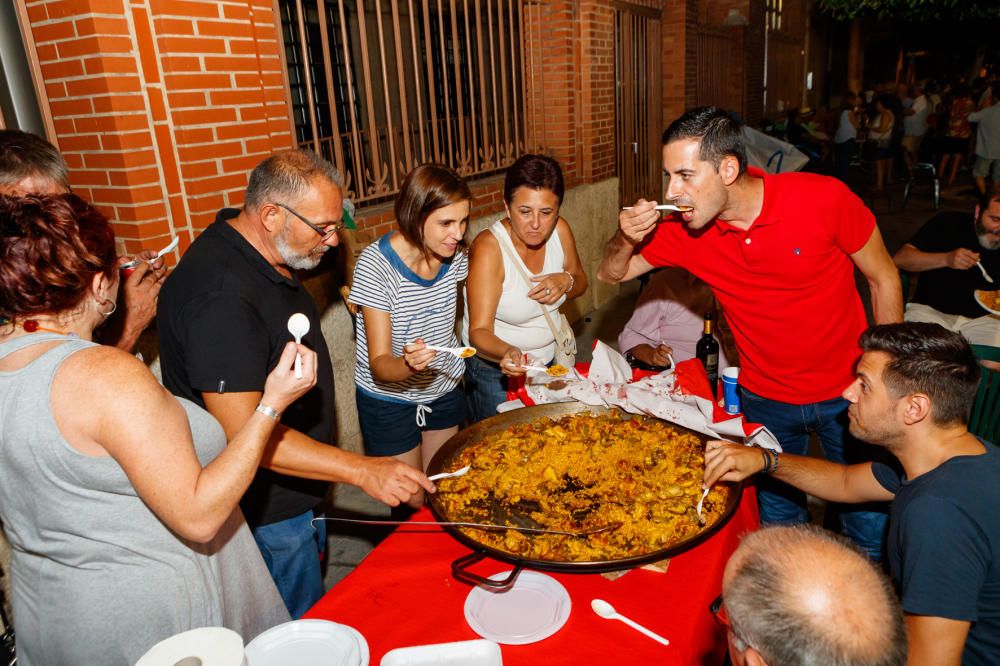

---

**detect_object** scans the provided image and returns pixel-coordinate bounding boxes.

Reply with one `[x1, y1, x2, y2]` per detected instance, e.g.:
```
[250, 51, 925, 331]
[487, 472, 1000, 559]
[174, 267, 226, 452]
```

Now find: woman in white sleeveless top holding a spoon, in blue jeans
[462, 155, 587, 421]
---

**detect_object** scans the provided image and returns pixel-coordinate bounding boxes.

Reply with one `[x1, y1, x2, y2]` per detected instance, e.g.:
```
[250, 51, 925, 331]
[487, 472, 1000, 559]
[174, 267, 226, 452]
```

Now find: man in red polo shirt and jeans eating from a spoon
[597, 107, 903, 559]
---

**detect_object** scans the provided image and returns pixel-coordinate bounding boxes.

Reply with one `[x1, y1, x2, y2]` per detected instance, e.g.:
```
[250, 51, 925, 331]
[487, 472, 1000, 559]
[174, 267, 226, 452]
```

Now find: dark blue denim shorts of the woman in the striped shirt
[354, 386, 465, 456]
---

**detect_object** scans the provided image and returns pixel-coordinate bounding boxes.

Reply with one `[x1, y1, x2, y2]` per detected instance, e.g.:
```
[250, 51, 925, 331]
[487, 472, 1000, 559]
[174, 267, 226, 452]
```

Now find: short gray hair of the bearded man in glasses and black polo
[243, 150, 346, 209]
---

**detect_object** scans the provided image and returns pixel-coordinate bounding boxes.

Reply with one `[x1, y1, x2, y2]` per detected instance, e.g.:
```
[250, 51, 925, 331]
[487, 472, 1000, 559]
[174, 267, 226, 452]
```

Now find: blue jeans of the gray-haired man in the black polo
[252, 511, 326, 620]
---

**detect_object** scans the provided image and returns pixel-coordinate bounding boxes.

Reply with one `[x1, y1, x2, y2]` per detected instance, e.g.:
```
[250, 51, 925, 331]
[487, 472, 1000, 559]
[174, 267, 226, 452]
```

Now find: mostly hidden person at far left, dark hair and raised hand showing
[0, 129, 167, 351]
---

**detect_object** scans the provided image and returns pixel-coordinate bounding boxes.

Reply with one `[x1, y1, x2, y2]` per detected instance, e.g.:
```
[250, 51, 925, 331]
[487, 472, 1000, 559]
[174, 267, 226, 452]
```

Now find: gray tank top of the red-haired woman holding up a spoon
[0, 334, 289, 666]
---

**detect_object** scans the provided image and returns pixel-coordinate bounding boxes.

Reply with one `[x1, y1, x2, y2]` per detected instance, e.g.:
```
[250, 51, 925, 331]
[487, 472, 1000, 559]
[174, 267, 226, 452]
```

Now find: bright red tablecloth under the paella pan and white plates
[305, 486, 759, 666]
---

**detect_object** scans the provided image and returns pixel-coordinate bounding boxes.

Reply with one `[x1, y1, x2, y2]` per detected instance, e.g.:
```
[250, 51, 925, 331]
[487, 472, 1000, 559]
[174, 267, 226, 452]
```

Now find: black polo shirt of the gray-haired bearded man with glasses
[156, 208, 334, 527]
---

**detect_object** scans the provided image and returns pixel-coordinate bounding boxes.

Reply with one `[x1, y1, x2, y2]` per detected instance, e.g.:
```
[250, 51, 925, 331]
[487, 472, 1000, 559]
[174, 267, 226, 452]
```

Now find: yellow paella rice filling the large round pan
[434, 412, 730, 562]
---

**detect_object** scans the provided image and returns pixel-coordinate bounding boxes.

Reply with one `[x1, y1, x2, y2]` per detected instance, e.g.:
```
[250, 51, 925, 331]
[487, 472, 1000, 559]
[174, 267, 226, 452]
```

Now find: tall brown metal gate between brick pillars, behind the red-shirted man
[613, 3, 663, 205]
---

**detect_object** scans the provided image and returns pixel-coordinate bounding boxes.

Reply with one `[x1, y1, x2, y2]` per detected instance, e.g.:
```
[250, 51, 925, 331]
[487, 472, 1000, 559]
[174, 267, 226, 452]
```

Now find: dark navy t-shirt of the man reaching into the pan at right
[872, 443, 1000, 666]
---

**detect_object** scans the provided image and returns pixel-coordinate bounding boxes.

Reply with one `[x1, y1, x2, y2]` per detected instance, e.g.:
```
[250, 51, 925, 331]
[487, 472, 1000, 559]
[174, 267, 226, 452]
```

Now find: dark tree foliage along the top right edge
[819, 0, 1000, 23]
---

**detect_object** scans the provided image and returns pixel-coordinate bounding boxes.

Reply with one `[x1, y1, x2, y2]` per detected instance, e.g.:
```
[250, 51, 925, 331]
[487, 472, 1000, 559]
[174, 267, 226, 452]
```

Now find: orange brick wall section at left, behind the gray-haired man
[27, 0, 291, 256]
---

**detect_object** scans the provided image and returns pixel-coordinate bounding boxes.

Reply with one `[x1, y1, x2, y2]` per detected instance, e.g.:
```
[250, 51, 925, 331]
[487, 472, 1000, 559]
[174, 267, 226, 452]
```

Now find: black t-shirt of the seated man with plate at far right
[909, 212, 1000, 318]
